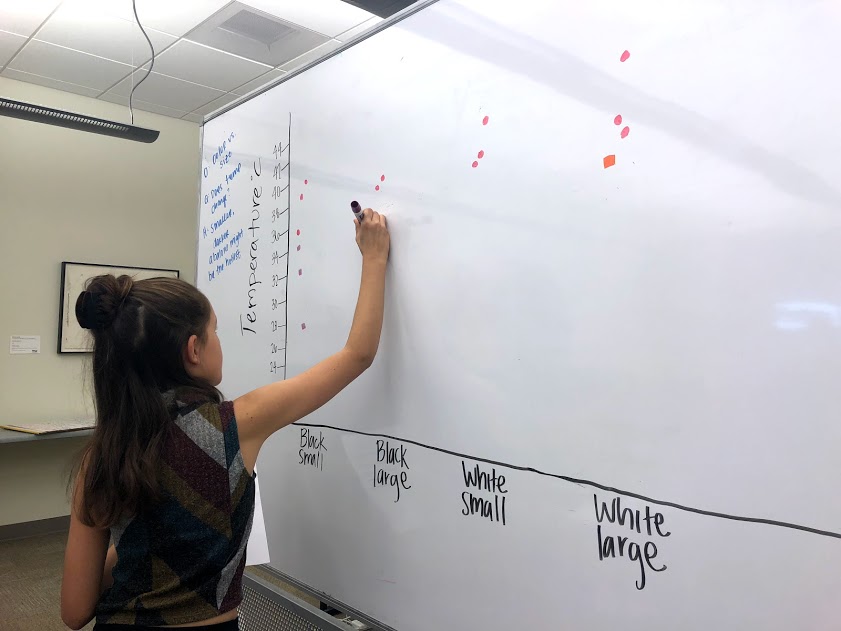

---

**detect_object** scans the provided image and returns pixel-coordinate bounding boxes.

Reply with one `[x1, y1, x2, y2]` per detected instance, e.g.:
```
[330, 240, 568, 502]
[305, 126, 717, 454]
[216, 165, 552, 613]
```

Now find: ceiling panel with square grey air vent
[185, 2, 329, 66]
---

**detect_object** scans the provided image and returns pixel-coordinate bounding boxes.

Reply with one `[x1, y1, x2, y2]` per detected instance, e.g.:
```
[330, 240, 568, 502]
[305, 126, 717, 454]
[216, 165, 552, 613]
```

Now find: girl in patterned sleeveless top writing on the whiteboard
[61, 209, 389, 631]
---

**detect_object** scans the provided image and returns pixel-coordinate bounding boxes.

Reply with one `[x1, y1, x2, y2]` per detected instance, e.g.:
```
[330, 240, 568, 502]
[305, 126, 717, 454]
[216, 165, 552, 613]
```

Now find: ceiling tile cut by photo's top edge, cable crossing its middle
[61, 0, 230, 37]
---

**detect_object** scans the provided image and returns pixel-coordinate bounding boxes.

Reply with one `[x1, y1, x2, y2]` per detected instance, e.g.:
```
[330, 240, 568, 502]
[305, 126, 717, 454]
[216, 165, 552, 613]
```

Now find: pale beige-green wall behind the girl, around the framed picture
[0, 78, 200, 525]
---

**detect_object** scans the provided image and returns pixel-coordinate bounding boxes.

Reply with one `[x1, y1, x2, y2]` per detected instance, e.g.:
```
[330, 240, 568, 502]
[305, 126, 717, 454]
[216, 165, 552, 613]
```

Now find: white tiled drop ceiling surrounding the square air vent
[0, 0, 381, 122]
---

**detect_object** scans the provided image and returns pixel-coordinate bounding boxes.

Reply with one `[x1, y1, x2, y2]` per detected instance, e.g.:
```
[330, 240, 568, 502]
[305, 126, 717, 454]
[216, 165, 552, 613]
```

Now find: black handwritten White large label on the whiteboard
[593, 493, 672, 590]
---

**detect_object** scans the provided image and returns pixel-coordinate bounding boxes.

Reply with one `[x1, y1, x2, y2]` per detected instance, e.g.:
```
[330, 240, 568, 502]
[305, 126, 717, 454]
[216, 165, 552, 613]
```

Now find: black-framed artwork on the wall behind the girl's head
[58, 261, 180, 353]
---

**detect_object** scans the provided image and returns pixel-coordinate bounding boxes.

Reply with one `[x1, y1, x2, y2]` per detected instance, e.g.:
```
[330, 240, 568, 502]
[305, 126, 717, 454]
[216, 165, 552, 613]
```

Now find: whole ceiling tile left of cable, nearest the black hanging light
[9, 40, 131, 90]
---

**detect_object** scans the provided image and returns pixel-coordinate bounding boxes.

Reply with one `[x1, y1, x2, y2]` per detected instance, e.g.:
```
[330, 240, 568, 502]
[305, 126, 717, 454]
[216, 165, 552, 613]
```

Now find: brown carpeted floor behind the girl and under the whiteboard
[0, 533, 318, 631]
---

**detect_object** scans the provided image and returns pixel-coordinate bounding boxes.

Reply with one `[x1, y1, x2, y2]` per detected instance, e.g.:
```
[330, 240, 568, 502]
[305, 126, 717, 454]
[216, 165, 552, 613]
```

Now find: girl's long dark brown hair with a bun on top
[74, 274, 221, 528]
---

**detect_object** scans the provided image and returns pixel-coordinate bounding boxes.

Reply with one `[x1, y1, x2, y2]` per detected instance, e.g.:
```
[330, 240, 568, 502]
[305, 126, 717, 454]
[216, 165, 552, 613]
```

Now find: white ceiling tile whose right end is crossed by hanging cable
[36, 2, 176, 66]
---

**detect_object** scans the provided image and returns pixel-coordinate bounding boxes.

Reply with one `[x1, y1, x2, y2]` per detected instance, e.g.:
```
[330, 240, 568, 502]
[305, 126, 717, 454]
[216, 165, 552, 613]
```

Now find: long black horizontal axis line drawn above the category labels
[294, 422, 841, 539]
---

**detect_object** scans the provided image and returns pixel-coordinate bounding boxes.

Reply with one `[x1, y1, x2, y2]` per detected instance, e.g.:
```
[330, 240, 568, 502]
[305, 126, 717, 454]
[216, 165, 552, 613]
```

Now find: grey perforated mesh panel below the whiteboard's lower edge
[239, 574, 351, 631]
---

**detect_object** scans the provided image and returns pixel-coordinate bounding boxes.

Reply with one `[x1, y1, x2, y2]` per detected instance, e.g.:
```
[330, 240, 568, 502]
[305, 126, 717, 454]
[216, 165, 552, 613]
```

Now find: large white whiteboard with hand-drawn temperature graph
[199, 0, 841, 631]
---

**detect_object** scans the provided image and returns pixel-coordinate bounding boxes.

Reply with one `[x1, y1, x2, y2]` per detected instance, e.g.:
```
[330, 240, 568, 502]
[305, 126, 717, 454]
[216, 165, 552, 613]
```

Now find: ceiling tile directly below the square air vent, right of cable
[150, 40, 271, 92]
